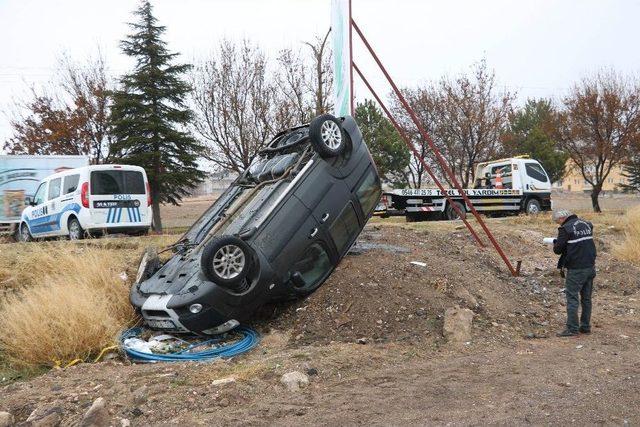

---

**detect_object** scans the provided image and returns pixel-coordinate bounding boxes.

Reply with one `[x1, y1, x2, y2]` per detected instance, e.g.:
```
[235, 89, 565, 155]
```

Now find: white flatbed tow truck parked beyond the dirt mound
[375, 156, 552, 222]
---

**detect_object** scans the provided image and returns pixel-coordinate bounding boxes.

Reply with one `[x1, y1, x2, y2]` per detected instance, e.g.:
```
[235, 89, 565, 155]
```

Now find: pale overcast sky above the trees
[0, 0, 640, 150]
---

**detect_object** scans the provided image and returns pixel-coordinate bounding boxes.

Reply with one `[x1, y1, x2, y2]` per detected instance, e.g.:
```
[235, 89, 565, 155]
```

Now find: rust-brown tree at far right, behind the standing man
[559, 71, 640, 212]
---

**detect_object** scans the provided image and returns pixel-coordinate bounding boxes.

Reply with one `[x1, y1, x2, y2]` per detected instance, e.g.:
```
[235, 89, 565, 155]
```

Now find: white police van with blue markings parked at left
[19, 165, 152, 241]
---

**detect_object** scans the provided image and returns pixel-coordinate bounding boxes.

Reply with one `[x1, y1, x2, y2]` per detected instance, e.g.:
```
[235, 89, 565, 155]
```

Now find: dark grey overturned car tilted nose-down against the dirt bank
[130, 114, 381, 334]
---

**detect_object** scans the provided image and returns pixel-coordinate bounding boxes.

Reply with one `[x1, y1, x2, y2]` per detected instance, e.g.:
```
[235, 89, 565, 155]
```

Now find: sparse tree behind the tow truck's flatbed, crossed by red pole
[392, 60, 514, 187]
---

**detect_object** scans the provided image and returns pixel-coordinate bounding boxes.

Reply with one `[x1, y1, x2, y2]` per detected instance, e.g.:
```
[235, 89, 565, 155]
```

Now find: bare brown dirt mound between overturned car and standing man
[263, 226, 559, 344]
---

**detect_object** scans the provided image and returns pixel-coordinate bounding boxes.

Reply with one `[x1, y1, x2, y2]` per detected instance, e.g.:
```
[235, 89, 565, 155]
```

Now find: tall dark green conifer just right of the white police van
[111, 1, 204, 231]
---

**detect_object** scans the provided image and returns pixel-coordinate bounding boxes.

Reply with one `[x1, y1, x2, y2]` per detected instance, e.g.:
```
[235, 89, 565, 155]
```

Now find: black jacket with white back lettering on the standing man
[553, 215, 596, 269]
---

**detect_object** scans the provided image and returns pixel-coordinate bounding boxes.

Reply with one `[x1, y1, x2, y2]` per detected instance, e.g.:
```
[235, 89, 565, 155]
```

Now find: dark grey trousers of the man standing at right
[565, 267, 596, 332]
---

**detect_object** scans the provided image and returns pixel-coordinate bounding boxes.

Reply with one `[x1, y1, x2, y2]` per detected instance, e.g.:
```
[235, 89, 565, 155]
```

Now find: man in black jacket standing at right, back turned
[553, 210, 596, 337]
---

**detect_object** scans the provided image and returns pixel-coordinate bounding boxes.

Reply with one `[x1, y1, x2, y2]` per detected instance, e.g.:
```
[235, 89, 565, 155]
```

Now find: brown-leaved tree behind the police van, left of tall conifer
[4, 51, 111, 163]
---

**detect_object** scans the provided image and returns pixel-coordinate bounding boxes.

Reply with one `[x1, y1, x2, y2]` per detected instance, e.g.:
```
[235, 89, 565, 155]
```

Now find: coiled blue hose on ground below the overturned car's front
[120, 326, 260, 362]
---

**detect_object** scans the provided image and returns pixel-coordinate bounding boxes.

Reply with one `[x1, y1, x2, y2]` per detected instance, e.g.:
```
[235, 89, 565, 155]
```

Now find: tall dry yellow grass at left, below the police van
[0, 236, 175, 369]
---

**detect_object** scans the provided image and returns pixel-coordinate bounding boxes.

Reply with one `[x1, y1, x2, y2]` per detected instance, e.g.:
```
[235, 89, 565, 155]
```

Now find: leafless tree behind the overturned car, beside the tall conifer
[192, 40, 284, 172]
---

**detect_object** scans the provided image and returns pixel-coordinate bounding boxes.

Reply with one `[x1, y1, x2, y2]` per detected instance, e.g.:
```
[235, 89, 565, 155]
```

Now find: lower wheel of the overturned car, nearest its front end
[200, 236, 252, 291]
